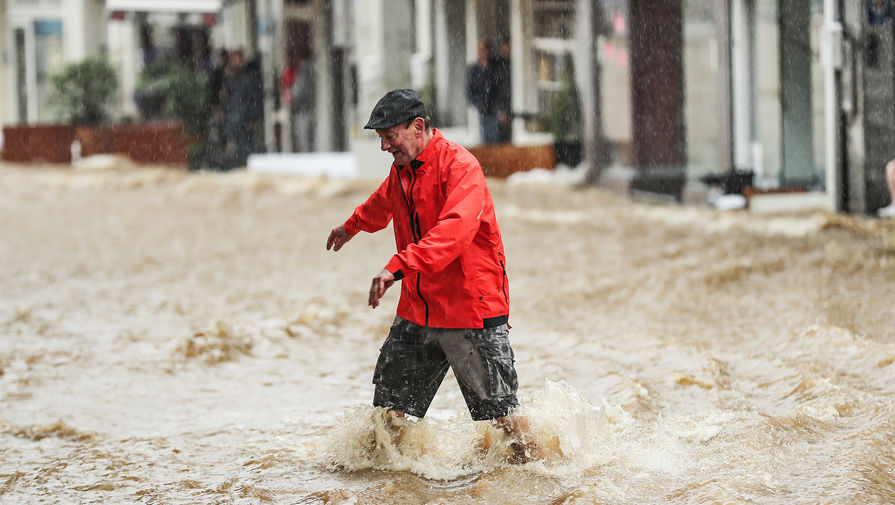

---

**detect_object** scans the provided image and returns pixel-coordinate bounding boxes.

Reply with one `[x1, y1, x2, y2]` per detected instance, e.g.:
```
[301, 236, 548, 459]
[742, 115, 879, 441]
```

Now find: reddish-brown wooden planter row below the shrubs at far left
[3, 121, 193, 165]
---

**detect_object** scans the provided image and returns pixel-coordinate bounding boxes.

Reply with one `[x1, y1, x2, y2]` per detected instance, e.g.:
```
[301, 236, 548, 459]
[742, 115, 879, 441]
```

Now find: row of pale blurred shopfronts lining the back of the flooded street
[0, 0, 895, 212]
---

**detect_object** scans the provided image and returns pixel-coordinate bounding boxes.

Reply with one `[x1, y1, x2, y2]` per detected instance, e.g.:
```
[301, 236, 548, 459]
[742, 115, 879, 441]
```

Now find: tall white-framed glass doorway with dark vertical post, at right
[731, 0, 824, 187]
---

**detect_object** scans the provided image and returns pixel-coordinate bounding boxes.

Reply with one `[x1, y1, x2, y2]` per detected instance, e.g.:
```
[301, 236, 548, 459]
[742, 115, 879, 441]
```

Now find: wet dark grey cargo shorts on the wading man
[373, 317, 519, 421]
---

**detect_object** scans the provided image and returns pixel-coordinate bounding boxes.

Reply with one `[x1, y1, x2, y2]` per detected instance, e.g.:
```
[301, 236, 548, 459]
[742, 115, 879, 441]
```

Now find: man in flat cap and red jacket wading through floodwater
[326, 89, 537, 462]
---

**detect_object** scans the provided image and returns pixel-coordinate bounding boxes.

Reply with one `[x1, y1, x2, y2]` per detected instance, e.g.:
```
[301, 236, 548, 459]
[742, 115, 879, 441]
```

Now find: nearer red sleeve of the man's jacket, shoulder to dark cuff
[385, 157, 486, 275]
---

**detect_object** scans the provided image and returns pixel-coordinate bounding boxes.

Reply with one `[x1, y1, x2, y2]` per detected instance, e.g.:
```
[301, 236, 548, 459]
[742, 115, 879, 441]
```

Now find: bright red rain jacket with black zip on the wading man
[345, 129, 509, 328]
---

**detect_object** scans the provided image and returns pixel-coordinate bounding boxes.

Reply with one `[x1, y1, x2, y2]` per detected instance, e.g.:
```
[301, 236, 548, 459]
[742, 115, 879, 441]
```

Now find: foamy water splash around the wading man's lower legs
[312, 381, 614, 480]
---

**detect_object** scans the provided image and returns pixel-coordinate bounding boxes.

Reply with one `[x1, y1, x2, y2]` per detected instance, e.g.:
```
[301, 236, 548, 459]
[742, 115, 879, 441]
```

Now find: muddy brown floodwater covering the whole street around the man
[0, 165, 895, 505]
